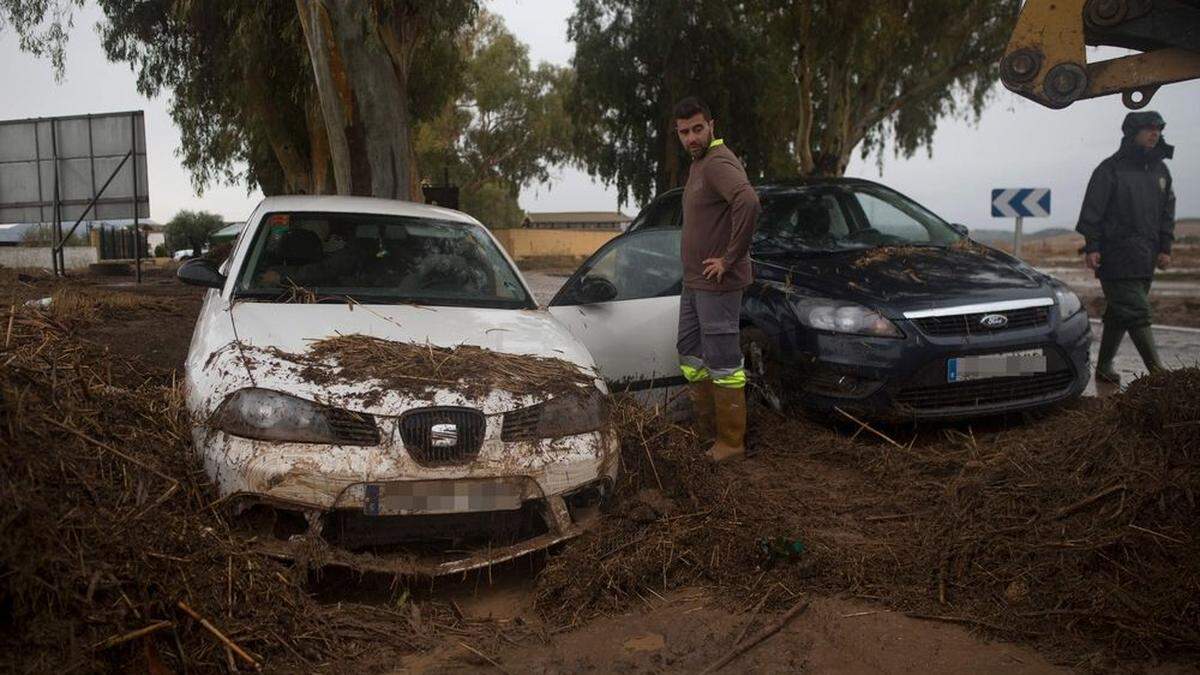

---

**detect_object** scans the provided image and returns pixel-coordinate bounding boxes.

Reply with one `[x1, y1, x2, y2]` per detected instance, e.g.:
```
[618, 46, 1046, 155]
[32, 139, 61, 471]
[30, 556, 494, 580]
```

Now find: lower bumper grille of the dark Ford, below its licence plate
[896, 370, 1074, 411]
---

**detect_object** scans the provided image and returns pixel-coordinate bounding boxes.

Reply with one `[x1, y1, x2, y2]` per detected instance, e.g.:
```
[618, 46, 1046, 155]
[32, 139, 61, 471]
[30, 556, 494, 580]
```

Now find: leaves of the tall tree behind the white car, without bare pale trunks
[0, 0, 479, 195]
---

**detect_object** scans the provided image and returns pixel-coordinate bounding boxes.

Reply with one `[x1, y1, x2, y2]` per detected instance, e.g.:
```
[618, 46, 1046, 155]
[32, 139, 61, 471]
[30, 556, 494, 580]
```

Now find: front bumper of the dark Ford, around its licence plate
[781, 310, 1091, 420]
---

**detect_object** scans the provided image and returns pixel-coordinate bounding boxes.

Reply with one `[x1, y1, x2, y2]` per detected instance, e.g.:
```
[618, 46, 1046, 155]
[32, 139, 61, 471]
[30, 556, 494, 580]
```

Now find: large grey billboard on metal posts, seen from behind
[0, 110, 150, 281]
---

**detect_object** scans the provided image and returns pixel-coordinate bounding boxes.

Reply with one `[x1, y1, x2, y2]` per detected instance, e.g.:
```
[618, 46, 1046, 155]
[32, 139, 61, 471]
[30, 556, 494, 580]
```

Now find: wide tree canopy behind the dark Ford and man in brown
[568, 0, 1020, 203]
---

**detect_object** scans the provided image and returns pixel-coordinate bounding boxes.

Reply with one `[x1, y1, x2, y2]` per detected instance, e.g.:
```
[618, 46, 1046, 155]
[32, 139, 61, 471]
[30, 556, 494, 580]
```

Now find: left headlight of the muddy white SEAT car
[212, 388, 379, 446]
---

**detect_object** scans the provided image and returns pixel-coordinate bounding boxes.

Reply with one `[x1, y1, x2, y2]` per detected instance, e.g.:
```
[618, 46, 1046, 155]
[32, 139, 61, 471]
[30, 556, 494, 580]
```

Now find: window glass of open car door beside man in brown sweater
[559, 228, 683, 304]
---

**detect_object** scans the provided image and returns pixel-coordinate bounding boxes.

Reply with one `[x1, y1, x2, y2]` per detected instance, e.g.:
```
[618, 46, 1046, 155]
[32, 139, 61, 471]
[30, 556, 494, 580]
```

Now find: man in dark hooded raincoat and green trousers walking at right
[1075, 112, 1175, 384]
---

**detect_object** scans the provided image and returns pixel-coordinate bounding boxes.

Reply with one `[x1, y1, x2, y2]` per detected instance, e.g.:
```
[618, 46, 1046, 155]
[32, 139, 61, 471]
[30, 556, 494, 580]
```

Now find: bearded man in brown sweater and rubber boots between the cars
[674, 97, 762, 462]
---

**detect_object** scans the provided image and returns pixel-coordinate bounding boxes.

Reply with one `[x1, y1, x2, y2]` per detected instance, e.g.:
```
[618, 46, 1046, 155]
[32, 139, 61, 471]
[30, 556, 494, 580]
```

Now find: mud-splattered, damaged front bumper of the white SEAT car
[196, 429, 619, 577]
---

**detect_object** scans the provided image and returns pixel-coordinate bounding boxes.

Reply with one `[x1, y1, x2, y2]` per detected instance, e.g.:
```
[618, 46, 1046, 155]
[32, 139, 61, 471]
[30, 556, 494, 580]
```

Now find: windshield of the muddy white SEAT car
[235, 211, 533, 309]
